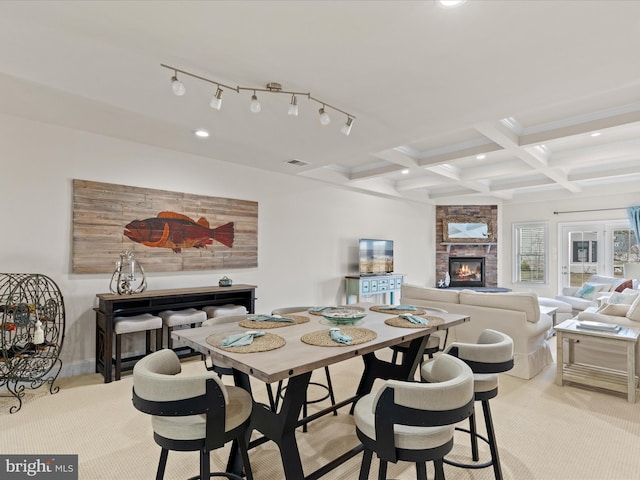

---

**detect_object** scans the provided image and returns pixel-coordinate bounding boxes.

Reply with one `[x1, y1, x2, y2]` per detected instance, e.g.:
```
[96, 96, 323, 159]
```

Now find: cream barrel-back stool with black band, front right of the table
[354, 354, 473, 480]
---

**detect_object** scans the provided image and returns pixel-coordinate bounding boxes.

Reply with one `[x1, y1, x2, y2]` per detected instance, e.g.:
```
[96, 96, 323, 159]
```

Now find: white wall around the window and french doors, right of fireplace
[498, 193, 640, 298]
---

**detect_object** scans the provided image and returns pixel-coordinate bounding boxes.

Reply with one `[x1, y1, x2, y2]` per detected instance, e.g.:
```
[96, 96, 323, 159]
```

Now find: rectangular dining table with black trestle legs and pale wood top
[172, 302, 470, 480]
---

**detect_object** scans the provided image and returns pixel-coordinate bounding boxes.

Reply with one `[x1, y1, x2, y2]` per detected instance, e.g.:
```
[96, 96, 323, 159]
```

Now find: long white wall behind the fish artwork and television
[0, 115, 435, 375]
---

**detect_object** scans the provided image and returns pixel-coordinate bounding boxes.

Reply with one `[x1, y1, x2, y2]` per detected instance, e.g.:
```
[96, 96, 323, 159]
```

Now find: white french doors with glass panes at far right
[559, 220, 638, 287]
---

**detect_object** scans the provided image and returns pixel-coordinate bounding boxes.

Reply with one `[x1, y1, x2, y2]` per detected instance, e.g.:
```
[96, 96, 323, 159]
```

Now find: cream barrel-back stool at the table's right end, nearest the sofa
[445, 329, 513, 480]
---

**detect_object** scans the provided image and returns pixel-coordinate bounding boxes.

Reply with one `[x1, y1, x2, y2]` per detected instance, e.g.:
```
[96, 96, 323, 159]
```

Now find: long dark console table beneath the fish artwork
[94, 285, 256, 383]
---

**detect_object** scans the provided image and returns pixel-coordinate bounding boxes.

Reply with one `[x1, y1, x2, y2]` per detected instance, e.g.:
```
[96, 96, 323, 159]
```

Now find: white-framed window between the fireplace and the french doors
[513, 223, 548, 283]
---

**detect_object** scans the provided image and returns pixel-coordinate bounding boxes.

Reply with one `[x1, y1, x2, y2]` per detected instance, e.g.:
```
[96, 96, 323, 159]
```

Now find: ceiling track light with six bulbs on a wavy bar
[160, 64, 356, 136]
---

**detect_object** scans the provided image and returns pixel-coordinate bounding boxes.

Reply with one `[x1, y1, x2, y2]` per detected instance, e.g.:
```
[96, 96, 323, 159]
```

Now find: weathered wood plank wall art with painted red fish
[73, 179, 258, 273]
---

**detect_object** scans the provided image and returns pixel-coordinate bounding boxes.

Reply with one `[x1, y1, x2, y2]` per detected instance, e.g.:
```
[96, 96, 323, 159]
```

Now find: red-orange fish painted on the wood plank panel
[124, 212, 234, 253]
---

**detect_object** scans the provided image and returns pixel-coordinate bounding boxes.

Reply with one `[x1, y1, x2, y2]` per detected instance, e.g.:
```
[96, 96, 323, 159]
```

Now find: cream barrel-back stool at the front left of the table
[133, 349, 253, 480]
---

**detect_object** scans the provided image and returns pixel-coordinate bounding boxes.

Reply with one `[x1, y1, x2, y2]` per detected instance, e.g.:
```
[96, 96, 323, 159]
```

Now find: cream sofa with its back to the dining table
[400, 285, 553, 379]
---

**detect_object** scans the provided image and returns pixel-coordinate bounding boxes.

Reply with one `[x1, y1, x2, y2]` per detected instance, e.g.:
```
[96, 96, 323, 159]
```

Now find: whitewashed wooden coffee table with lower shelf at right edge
[554, 319, 640, 403]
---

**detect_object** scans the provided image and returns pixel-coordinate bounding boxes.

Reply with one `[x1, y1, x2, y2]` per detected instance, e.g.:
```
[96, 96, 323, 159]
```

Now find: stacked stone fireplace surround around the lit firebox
[434, 205, 500, 287]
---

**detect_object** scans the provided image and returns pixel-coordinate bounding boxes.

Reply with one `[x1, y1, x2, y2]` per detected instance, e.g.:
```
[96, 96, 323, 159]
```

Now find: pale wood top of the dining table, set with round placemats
[172, 303, 469, 383]
